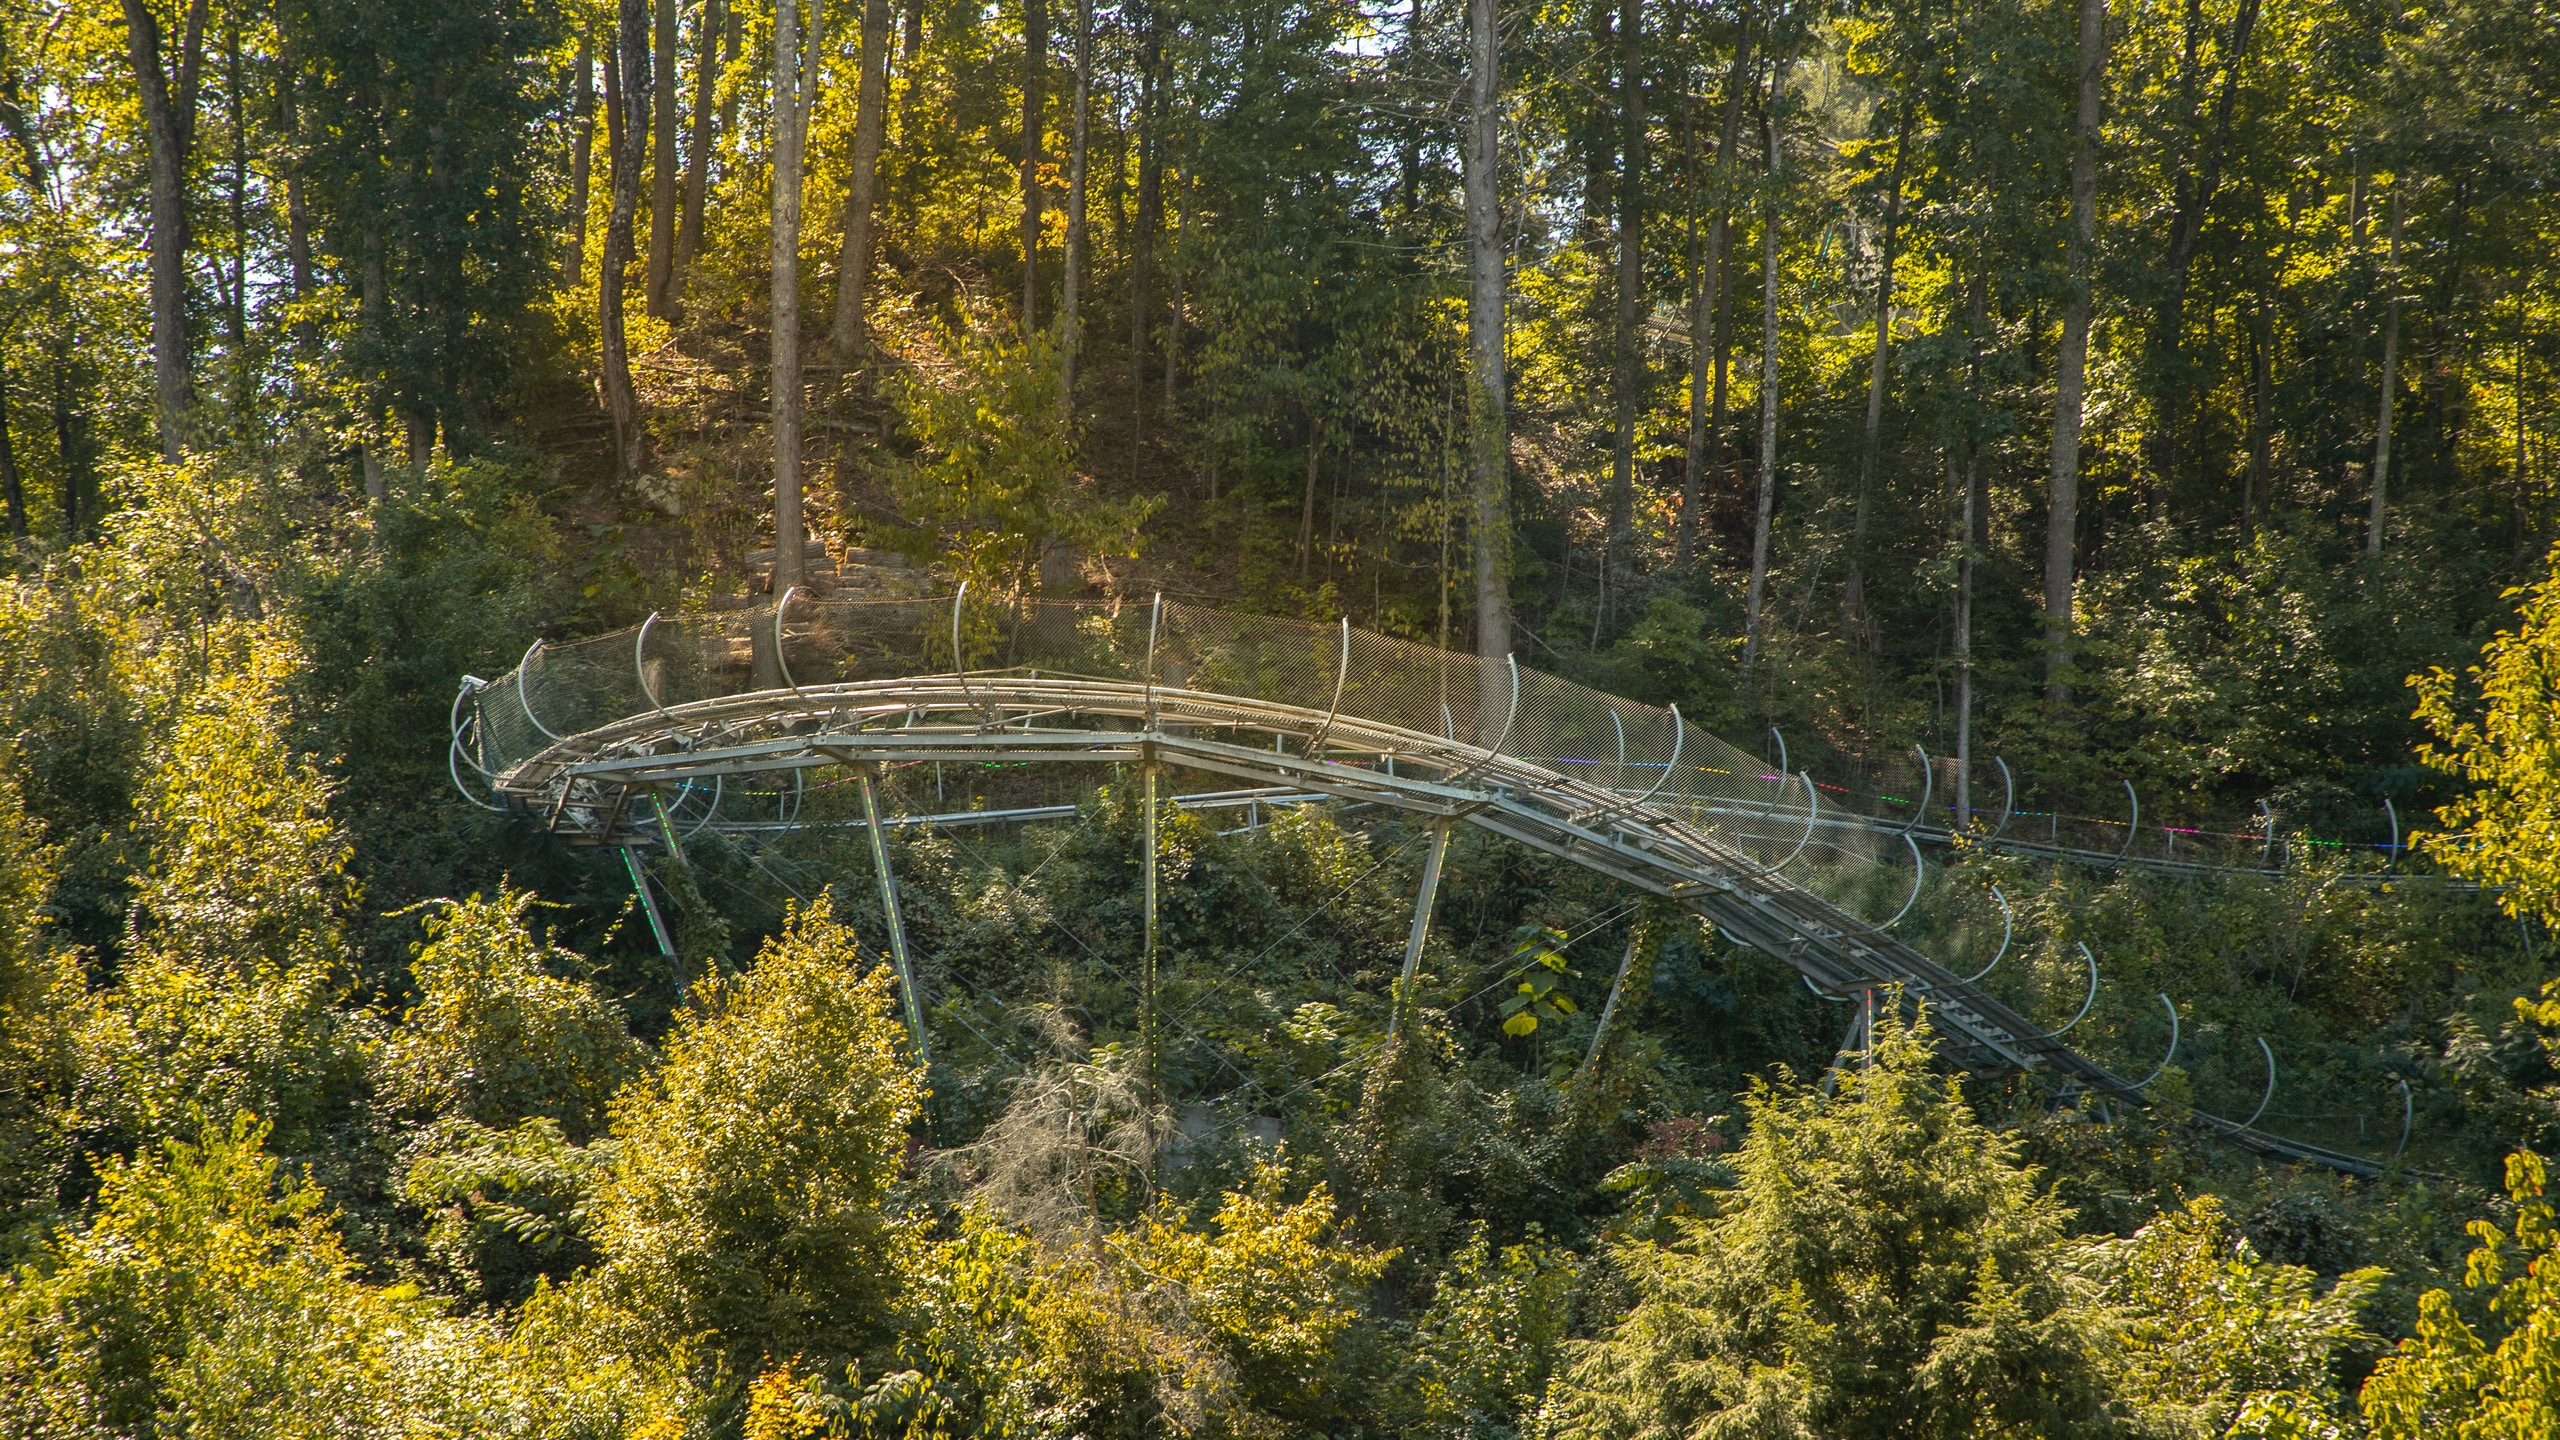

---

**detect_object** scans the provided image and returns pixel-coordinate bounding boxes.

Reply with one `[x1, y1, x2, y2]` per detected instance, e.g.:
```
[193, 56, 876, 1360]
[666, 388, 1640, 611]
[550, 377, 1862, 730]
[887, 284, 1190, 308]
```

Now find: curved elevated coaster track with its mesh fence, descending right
[453, 589, 2378, 1174]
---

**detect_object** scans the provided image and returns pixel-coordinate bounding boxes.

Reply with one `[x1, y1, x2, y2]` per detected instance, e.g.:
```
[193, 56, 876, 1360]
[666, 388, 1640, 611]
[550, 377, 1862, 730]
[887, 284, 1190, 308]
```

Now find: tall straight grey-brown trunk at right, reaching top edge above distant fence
[2045, 0, 2107, 705]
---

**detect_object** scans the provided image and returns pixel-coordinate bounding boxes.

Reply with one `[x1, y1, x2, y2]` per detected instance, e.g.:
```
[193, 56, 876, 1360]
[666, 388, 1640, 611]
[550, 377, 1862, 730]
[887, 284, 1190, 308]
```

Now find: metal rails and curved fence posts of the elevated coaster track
[453, 597, 2381, 1176]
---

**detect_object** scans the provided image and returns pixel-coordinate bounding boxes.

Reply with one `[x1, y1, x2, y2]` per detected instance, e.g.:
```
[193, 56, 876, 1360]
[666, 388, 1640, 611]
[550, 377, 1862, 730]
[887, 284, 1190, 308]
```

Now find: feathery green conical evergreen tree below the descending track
[1549, 1004, 2120, 1440]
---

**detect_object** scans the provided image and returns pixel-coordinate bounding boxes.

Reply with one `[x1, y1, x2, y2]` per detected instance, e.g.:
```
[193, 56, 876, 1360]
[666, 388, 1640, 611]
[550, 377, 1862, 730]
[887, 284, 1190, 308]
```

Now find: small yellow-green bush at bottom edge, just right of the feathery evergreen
[2084, 1197, 2383, 1437]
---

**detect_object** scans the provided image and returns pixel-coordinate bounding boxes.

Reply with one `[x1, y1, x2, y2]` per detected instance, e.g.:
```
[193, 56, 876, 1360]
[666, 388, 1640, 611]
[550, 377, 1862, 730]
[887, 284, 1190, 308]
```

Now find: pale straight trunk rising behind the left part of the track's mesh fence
[773, 0, 827, 594]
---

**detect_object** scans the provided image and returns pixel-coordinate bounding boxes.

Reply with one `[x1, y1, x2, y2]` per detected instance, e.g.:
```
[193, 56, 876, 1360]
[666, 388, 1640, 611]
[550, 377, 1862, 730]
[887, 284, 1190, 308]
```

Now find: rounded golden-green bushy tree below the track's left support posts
[589, 897, 922, 1389]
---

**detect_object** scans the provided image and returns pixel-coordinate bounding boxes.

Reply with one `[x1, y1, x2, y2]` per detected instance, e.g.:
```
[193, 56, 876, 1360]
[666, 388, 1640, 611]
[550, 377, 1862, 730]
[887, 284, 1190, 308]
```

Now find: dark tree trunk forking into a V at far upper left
[123, 0, 205, 461]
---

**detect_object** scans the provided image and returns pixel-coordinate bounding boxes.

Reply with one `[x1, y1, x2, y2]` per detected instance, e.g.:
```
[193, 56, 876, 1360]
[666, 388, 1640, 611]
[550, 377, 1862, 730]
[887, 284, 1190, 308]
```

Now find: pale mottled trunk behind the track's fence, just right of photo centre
[1464, 0, 1510, 712]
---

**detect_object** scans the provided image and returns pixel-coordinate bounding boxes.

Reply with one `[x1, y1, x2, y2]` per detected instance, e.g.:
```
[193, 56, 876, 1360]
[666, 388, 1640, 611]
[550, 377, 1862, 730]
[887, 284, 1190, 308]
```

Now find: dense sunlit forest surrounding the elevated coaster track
[0, 0, 2560, 1440]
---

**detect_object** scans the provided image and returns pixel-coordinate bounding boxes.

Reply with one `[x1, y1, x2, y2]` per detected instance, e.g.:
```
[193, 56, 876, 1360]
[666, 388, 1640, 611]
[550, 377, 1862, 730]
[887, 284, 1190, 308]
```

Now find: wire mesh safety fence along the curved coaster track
[458, 594, 2396, 889]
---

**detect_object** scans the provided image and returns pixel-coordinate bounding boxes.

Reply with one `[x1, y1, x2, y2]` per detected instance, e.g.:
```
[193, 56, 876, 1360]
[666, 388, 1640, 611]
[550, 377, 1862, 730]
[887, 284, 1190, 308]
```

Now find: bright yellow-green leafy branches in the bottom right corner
[2363, 1150, 2560, 1440]
